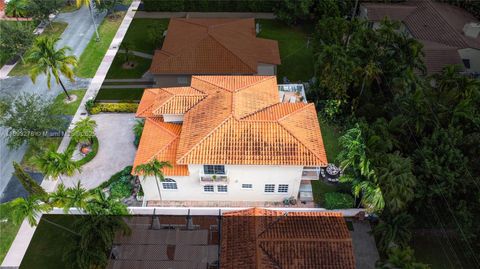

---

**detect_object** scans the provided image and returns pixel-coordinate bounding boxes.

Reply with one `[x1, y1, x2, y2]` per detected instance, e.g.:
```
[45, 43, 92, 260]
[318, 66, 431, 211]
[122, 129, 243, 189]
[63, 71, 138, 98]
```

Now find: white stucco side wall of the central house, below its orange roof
[142, 165, 303, 201]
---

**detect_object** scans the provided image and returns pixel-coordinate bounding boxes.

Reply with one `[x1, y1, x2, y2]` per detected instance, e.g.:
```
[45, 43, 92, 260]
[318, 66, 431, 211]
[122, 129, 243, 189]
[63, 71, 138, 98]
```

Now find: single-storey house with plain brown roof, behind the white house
[149, 18, 280, 87]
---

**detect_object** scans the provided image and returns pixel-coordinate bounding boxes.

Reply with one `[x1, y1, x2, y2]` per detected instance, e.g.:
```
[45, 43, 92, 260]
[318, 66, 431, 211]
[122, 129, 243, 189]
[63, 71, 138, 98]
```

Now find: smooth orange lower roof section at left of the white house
[133, 117, 189, 176]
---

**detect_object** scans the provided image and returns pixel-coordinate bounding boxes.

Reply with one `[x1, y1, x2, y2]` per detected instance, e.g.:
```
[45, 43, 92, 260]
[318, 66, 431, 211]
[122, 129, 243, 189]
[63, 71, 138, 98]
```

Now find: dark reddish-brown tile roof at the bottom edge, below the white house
[220, 208, 355, 269]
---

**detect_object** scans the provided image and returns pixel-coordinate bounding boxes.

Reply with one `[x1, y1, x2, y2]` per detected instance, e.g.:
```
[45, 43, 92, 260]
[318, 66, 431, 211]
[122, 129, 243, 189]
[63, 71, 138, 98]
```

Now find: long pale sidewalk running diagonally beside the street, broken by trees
[0, 0, 140, 269]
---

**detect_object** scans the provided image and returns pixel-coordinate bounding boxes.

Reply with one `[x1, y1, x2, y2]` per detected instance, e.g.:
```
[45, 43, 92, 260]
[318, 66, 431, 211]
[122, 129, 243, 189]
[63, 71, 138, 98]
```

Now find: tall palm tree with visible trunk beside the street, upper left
[27, 36, 77, 100]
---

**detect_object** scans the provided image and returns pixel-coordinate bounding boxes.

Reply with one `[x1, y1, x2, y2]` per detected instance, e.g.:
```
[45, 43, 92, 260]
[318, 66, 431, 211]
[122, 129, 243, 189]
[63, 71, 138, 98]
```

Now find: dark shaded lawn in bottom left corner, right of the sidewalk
[20, 215, 75, 269]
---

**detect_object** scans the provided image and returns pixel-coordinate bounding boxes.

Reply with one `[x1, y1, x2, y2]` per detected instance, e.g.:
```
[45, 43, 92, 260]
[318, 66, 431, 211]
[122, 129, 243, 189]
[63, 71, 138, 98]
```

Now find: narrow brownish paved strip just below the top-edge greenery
[136, 11, 276, 19]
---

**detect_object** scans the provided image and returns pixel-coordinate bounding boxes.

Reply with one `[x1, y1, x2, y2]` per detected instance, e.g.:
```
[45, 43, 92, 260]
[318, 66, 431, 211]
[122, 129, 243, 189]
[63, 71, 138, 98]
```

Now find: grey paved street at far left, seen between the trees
[0, 7, 104, 196]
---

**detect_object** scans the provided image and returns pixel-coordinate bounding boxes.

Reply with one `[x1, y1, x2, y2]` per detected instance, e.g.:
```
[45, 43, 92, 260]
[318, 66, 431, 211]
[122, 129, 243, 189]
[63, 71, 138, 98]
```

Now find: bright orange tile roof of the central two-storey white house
[134, 76, 327, 175]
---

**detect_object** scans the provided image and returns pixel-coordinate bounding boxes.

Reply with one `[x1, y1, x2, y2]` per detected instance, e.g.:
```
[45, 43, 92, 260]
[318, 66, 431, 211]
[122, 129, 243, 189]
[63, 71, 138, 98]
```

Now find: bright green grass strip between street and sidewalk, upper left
[75, 12, 125, 78]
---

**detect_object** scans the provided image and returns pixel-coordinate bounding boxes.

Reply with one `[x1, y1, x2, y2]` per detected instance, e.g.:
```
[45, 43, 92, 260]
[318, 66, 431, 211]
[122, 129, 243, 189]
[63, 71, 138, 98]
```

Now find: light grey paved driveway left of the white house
[63, 113, 137, 189]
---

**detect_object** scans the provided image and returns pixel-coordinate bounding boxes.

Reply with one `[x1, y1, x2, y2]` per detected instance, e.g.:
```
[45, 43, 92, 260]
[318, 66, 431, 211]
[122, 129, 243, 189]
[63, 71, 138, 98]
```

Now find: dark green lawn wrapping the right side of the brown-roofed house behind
[257, 20, 314, 82]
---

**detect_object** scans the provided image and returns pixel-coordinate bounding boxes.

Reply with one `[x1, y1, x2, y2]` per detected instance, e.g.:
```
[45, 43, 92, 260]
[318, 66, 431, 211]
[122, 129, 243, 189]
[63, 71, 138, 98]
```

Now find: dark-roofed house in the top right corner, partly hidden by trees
[360, 0, 480, 74]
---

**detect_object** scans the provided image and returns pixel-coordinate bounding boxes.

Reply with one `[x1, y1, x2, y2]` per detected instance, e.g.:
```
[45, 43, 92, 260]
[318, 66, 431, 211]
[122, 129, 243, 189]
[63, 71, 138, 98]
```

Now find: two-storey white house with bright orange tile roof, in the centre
[134, 76, 327, 202]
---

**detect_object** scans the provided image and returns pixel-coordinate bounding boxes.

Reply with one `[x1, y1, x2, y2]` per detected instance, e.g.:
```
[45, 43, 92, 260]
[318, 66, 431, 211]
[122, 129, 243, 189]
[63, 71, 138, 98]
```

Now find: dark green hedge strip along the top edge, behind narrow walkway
[143, 0, 281, 12]
